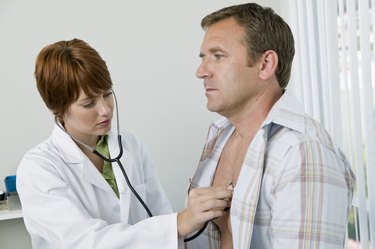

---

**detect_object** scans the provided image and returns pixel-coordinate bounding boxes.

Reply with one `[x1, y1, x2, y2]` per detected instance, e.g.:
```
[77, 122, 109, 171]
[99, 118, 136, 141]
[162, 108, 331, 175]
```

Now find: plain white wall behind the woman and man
[0, 0, 281, 249]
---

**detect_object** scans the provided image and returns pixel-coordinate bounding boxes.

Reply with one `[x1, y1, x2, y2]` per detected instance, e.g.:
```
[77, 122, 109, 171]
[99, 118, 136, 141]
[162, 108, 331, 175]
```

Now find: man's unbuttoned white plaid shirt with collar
[186, 92, 355, 249]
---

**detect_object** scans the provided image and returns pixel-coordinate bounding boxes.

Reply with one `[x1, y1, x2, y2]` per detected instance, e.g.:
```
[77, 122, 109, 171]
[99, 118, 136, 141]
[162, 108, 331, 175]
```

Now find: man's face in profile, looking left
[196, 18, 261, 117]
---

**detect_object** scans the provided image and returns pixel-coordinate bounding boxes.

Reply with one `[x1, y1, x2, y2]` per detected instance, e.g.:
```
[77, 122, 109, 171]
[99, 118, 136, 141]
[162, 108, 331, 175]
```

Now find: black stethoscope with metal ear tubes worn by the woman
[55, 90, 208, 242]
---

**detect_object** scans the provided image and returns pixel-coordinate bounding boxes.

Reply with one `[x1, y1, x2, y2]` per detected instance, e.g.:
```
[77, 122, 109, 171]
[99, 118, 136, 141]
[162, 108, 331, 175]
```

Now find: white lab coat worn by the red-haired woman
[17, 126, 178, 249]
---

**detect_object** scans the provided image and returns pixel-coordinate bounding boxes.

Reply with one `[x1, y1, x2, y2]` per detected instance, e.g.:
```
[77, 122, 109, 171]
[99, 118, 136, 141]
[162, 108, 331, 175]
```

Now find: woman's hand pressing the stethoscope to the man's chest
[177, 187, 233, 238]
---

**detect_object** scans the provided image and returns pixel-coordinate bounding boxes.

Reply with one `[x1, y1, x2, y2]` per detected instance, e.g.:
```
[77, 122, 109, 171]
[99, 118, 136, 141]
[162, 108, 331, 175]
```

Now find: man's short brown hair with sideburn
[201, 3, 295, 88]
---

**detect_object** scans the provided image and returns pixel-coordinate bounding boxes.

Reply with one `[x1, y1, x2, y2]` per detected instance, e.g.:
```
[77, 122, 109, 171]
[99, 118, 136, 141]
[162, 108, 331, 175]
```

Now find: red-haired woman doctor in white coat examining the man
[17, 39, 232, 249]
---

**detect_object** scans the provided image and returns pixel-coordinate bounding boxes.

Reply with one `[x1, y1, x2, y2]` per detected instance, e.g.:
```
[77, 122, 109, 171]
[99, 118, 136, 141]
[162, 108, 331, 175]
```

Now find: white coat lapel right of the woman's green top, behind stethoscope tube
[108, 135, 133, 222]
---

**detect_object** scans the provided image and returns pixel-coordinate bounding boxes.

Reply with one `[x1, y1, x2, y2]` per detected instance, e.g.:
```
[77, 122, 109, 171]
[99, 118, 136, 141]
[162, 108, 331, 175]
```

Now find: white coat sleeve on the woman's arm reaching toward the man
[17, 152, 178, 249]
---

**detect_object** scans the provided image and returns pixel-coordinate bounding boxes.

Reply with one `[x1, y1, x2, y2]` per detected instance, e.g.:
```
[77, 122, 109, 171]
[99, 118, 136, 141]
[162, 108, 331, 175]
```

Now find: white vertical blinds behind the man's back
[283, 0, 375, 249]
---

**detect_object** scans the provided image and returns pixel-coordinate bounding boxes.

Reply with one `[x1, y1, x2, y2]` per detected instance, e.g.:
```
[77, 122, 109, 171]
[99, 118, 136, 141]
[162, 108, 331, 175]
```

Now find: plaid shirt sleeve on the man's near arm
[271, 142, 354, 249]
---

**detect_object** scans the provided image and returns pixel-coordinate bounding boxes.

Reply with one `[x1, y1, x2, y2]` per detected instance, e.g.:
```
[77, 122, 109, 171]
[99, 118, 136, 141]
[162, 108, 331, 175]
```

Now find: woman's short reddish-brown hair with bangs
[35, 39, 112, 120]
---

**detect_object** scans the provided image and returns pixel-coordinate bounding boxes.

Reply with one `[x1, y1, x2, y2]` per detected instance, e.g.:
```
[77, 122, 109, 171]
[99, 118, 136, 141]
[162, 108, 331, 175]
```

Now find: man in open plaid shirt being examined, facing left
[187, 3, 355, 249]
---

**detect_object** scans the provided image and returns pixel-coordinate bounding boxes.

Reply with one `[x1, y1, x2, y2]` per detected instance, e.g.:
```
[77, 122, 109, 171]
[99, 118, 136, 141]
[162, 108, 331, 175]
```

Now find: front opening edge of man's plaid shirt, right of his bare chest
[231, 127, 267, 249]
